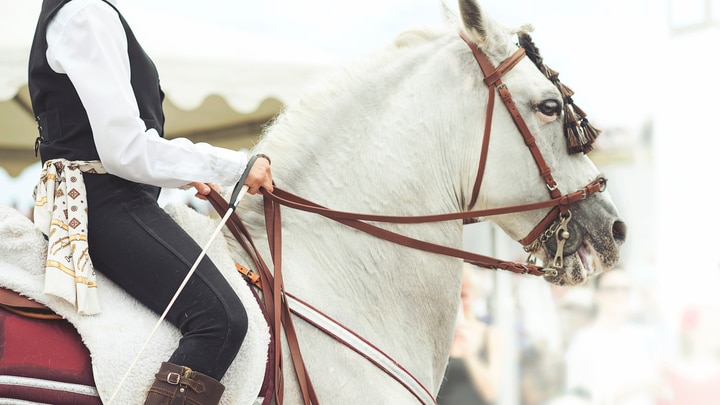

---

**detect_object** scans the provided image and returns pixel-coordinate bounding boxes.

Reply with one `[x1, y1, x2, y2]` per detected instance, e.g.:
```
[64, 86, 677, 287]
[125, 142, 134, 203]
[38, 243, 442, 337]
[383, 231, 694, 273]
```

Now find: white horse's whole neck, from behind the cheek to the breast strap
[242, 32, 484, 385]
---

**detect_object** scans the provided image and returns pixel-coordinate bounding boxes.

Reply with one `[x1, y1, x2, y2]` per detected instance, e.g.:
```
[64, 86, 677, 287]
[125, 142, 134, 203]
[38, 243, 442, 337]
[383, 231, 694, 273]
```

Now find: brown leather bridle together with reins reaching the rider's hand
[248, 34, 607, 276]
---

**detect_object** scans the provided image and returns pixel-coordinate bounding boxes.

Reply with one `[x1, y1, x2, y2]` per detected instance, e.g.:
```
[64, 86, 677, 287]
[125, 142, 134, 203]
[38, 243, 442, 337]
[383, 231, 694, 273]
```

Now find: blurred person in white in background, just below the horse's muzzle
[565, 268, 659, 405]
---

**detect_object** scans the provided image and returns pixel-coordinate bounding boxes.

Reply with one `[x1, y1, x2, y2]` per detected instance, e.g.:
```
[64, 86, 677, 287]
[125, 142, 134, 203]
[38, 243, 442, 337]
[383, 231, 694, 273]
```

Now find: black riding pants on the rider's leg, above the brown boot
[84, 174, 248, 380]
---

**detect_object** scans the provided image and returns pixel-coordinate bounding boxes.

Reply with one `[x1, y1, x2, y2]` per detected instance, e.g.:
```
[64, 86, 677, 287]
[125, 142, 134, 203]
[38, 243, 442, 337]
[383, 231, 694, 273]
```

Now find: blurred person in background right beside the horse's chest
[437, 264, 502, 405]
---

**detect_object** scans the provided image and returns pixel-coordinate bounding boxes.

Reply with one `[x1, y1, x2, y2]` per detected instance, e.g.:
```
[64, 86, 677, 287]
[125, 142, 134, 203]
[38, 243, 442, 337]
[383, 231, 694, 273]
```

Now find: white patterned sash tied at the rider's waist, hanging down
[33, 159, 107, 315]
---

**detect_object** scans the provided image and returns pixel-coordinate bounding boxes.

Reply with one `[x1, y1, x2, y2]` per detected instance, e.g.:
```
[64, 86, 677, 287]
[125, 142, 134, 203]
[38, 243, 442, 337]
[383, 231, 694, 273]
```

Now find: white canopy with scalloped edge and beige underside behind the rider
[0, 0, 335, 176]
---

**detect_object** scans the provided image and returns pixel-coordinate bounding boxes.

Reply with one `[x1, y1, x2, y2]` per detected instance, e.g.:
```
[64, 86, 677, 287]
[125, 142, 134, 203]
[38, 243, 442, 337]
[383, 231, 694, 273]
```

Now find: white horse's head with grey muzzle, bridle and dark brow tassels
[460, 0, 626, 285]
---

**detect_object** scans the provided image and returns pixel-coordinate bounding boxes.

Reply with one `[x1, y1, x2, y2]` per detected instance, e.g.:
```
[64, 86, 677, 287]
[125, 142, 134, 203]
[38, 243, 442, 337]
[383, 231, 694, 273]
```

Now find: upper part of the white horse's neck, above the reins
[257, 36, 479, 215]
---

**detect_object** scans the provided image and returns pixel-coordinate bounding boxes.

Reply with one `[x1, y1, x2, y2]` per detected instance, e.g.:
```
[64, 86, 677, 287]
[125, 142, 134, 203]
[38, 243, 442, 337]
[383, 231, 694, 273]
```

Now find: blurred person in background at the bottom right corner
[659, 306, 720, 405]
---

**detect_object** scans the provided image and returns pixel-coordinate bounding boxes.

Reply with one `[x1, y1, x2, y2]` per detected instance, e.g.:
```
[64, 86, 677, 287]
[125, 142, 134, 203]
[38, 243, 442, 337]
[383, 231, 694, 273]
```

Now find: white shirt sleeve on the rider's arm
[47, 0, 247, 187]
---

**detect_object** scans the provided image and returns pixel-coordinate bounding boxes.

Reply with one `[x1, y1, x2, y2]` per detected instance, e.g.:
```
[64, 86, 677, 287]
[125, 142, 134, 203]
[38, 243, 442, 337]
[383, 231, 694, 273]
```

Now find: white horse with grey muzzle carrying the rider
[0, 0, 625, 404]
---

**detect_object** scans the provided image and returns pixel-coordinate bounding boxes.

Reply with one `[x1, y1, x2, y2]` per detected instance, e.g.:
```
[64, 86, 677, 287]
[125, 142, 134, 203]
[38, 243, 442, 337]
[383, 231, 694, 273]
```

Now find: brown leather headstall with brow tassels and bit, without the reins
[460, 32, 607, 276]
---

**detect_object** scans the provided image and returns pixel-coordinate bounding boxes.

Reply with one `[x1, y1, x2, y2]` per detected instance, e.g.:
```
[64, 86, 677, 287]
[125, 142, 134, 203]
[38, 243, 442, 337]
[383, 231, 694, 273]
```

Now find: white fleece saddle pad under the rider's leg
[0, 204, 270, 405]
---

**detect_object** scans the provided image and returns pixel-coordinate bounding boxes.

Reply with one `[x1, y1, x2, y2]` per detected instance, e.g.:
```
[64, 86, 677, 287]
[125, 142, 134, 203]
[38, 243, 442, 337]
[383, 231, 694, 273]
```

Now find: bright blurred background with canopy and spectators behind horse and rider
[0, 0, 720, 405]
